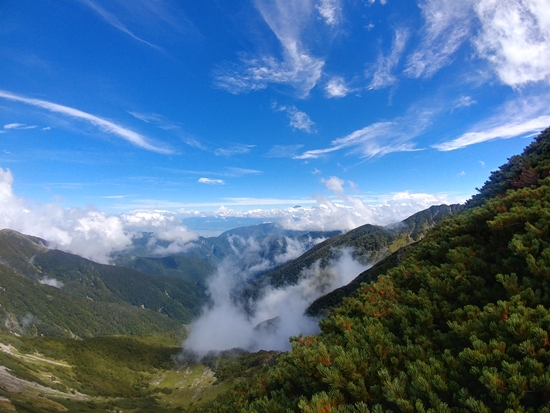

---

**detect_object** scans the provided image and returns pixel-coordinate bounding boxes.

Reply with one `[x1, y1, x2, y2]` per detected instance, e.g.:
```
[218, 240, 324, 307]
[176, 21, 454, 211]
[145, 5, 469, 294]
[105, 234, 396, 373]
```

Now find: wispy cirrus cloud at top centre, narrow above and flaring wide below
[214, 0, 325, 98]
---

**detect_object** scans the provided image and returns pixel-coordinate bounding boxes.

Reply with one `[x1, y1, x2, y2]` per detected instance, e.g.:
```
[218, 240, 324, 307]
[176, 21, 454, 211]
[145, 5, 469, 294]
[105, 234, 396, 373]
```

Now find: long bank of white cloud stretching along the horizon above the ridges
[0, 168, 458, 263]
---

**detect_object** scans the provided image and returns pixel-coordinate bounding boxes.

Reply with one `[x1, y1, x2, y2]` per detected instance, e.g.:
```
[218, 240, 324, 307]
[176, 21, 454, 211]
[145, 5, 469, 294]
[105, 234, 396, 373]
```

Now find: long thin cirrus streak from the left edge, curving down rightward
[0, 90, 172, 154]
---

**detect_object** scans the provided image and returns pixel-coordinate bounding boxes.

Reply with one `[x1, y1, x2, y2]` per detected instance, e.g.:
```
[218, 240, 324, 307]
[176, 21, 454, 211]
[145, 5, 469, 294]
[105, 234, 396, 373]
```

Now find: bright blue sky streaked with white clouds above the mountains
[0, 0, 550, 260]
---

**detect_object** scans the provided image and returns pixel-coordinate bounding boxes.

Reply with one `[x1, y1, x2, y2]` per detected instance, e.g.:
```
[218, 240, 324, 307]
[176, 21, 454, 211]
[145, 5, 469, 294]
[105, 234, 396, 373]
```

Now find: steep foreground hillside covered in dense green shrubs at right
[201, 129, 550, 413]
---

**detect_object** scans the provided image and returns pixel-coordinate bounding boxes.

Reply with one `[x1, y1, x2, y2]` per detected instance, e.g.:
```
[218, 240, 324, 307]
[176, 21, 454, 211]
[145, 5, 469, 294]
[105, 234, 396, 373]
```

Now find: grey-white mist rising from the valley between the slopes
[184, 243, 367, 357]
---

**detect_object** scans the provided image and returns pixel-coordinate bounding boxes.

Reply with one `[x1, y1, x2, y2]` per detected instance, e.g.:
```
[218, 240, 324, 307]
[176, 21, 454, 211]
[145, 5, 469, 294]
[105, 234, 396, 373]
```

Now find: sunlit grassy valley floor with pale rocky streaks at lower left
[0, 333, 275, 413]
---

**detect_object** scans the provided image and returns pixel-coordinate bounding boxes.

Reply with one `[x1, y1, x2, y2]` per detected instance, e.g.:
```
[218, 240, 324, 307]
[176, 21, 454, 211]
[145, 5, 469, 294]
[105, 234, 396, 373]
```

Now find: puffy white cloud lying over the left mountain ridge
[0, 168, 197, 262]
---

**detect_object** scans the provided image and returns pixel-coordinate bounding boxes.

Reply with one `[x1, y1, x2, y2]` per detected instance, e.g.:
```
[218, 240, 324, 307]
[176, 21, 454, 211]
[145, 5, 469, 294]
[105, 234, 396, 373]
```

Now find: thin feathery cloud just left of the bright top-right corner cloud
[405, 0, 474, 78]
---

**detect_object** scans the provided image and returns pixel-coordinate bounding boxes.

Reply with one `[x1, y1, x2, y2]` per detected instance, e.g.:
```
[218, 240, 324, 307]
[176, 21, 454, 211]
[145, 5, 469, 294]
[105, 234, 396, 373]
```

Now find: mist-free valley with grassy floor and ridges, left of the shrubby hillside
[0, 196, 460, 412]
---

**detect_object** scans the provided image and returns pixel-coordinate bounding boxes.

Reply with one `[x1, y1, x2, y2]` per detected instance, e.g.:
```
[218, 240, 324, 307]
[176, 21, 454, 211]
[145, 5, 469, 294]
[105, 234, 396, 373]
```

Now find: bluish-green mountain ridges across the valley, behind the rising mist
[0, 205, 461, 337]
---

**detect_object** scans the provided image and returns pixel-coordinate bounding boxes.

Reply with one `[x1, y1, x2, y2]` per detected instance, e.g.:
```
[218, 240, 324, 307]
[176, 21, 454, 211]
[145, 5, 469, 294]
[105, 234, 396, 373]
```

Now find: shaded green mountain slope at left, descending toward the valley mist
[0, 230, 206, 337]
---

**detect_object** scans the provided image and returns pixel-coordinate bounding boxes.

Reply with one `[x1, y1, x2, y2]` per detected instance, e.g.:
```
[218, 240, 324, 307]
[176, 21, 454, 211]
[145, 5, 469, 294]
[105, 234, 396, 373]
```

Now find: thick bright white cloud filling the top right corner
[474, 0, 550, 87]
